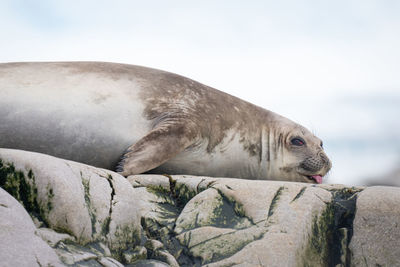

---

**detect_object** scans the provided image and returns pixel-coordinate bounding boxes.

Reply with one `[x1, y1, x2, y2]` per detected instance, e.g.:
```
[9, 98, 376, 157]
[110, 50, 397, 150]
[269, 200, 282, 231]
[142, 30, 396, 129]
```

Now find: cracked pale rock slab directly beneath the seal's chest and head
[128, 175, 356, 266]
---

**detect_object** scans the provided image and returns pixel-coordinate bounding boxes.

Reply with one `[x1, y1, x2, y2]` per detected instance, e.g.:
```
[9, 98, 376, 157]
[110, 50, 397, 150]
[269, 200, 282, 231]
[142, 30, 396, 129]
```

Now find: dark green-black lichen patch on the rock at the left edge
[0, 160, 48, 224]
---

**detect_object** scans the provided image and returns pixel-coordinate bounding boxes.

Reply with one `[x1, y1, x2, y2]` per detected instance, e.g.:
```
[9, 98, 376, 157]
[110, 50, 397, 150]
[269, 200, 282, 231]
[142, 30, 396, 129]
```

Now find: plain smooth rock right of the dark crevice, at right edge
[350, 186, 400, 266]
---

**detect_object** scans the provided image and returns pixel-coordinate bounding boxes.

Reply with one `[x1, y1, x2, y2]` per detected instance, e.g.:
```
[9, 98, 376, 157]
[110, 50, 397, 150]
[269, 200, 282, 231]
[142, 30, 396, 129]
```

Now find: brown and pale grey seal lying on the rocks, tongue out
[0, 62, 331, 183]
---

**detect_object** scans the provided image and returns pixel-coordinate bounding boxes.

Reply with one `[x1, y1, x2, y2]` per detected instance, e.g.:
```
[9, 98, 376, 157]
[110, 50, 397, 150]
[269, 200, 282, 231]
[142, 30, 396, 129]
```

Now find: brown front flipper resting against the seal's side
[116, 124, 197, 176]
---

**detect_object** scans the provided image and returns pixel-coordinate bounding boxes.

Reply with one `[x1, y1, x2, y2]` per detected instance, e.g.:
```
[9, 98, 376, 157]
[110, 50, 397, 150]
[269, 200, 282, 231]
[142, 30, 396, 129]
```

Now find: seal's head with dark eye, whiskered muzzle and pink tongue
[271, 121, 332, 184]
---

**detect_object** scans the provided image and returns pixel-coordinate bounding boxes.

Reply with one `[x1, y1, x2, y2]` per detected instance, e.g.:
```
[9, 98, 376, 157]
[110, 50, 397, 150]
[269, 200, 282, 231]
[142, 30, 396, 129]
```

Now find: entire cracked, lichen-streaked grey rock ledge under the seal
[0, 149, 400, 266]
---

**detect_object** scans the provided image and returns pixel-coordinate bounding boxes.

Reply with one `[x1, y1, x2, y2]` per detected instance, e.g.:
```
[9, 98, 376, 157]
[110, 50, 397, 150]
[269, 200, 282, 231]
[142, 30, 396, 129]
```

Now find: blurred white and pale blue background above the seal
[0, 0, 400, 185]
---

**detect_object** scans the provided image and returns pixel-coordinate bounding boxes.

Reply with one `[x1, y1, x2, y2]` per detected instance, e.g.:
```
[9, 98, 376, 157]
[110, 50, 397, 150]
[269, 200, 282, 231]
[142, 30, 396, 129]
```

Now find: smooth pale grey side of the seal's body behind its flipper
[0, 62, 150, 169]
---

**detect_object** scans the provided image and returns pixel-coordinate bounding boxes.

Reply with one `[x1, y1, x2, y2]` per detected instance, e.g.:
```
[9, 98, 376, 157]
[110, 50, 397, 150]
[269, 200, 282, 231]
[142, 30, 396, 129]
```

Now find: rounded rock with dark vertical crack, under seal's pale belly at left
[0, 149, 142, 264]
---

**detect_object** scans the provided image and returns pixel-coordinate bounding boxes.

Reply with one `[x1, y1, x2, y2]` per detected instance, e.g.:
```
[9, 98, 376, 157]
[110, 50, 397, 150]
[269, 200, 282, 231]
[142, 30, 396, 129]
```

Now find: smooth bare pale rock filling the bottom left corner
[0, 188, 63, 266]
